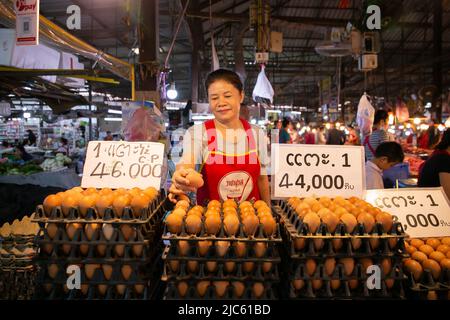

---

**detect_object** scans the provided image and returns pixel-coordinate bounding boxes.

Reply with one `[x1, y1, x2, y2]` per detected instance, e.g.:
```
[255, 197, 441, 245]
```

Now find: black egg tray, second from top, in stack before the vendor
[166, 242, 281, 263]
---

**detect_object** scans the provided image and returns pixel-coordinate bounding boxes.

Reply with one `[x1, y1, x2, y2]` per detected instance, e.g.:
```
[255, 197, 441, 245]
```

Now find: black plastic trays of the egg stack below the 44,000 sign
[273, 201, 408, 299]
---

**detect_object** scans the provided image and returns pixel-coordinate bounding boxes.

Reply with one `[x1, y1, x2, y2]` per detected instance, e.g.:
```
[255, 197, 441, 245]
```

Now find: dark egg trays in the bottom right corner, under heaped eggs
[407, 269, 450, 300]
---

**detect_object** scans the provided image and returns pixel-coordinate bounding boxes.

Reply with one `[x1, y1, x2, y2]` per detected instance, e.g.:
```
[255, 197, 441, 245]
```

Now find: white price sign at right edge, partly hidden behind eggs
[365, 188, 450, 238]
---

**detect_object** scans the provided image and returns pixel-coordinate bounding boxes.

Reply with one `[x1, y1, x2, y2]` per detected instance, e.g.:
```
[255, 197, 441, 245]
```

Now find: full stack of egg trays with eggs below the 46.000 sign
[34, 187, 164, 299]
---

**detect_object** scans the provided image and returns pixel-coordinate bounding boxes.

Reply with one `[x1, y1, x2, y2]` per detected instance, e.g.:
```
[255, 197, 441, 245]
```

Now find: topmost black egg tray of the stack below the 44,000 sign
[273, 201, 407, 239]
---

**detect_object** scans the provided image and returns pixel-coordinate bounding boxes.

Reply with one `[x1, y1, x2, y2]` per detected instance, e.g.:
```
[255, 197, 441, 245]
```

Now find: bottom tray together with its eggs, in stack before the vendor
[164, 280, 278, 300]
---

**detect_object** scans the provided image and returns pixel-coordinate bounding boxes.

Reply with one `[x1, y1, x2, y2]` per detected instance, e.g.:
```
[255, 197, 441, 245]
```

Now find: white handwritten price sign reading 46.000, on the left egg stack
[81, 141, 164, 189]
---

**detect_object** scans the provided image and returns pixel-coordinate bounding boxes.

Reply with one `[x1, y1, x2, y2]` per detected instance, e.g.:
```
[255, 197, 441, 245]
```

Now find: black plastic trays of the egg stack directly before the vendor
[162, 208, 282, 299]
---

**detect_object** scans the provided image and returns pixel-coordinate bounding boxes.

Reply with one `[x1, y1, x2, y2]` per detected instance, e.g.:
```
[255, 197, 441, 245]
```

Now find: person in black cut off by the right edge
[417, 129, 450, 199]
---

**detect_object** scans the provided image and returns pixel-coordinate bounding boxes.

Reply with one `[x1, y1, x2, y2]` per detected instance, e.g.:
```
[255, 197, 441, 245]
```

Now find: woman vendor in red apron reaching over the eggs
[169, 69, 270, 205]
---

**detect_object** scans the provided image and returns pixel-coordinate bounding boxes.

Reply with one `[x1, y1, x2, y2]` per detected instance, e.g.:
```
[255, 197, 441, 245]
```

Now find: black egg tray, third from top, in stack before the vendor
[162, 261, 280, 282]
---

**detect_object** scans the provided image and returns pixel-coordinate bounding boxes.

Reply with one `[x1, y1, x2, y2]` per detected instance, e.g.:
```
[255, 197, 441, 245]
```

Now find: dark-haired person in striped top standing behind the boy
[363, 110, 389, 161]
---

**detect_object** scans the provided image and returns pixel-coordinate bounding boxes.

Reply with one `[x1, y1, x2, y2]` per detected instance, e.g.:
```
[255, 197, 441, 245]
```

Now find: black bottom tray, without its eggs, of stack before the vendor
[164, 280, 279, 300]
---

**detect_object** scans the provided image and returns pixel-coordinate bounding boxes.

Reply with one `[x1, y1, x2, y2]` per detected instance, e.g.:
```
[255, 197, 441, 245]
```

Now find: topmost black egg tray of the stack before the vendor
[162, 211, 282, 242]
